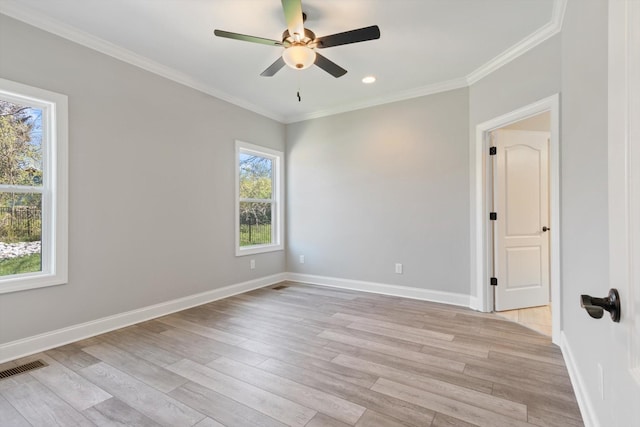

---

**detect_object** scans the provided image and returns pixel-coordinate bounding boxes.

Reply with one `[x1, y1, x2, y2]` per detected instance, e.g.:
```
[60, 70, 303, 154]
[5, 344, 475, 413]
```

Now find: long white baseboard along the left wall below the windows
[0, 273, 287, 363]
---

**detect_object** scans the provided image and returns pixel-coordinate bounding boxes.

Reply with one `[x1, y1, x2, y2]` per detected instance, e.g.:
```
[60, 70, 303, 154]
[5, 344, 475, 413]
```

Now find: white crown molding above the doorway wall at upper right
[466, 0, 567, 86]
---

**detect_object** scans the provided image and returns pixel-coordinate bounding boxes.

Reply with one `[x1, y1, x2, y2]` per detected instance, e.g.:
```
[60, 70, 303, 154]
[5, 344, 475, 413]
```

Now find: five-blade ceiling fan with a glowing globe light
[214, 0, 380, 78]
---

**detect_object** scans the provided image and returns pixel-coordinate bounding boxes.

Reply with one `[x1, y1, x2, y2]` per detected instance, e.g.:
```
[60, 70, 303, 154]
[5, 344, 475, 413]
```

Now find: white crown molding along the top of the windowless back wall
[284, 78, 468, 124]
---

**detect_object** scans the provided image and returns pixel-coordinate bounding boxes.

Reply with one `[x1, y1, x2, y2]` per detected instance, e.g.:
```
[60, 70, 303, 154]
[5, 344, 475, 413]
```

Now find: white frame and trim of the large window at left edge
[0, 79, 69, 294]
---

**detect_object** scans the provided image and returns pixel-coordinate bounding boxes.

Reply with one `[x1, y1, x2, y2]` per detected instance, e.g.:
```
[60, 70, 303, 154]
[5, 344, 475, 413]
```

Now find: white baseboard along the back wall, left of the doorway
[287, 273, 471, 307]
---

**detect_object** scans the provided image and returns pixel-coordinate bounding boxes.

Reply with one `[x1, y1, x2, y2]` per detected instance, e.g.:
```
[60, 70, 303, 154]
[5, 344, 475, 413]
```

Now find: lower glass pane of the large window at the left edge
[0, 193, 42, 276]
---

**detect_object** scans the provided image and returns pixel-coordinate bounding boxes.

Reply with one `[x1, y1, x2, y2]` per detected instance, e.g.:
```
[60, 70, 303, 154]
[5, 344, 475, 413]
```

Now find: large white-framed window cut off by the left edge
[0, 79, 67, 293]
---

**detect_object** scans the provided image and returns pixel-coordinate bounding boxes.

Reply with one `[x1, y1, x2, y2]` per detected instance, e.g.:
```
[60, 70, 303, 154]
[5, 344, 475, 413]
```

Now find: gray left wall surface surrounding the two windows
[0, 15, 285, 343]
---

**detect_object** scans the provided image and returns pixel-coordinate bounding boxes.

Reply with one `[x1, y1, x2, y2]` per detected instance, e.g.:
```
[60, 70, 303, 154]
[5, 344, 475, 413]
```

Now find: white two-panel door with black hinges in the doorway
[492, 129, 552, 311]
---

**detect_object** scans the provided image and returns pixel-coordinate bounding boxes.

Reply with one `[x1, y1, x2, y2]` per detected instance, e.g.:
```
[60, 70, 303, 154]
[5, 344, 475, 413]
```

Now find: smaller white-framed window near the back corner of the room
[236, 141, 284, 256]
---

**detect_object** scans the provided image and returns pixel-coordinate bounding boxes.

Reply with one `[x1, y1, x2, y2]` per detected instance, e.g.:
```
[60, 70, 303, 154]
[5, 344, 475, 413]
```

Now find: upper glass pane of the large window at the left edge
[0, 99, 42, 186]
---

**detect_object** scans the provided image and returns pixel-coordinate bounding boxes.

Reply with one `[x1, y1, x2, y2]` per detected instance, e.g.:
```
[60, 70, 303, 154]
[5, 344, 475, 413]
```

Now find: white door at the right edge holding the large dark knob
[602, 0, 640, 427]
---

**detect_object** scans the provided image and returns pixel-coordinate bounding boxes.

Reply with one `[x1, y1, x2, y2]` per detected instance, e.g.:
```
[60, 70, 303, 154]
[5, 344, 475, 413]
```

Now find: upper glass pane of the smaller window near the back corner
[240, 153, 273, 199]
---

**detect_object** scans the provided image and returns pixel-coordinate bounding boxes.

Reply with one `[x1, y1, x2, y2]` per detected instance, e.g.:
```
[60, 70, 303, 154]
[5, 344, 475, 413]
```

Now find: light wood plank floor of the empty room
[0, 283, 583, 427]
